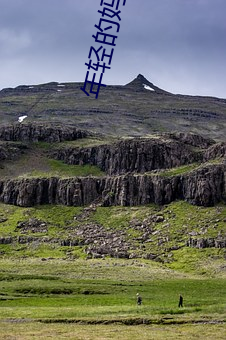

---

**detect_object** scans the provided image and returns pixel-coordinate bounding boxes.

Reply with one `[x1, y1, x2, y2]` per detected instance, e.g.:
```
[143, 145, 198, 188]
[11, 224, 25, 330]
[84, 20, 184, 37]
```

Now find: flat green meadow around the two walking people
[0, 258, 226, 339]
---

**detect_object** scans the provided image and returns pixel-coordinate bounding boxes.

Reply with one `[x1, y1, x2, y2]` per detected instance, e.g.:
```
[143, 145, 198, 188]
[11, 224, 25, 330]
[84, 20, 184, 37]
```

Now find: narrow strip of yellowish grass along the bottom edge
[0, 322, 225, 340]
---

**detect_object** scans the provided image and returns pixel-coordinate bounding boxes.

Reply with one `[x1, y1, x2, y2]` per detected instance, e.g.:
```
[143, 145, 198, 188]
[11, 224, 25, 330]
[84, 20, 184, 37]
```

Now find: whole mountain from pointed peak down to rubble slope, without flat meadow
[0, 75, 226, 273]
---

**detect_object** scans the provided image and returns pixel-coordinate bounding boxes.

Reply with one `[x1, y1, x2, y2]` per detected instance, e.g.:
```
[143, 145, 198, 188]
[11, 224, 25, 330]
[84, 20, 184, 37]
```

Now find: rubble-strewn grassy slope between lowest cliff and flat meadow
[0, 201, 226, 277]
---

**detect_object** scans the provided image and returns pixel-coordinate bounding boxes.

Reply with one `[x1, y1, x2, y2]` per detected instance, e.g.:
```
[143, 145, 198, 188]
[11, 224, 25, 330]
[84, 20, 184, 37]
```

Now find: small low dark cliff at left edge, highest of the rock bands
[0, 123, 91, 143]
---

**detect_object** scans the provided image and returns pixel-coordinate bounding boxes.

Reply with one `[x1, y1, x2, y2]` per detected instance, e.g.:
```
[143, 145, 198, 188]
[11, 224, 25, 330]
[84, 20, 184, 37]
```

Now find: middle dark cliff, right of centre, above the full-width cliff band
[52, 138, 202, 175]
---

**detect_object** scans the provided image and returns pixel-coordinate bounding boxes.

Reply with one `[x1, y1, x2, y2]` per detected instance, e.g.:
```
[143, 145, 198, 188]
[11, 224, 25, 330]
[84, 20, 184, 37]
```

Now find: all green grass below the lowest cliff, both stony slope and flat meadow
[0, 201, 226, 340]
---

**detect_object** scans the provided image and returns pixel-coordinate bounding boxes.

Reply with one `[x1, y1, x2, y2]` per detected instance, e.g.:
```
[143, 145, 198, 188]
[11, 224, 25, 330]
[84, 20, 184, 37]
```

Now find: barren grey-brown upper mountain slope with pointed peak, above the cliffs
[0, 74, 226, 140]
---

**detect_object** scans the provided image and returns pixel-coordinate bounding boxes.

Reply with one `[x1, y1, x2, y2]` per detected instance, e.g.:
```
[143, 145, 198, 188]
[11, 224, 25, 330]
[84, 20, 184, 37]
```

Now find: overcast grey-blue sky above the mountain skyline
[0, 0, 226, 98]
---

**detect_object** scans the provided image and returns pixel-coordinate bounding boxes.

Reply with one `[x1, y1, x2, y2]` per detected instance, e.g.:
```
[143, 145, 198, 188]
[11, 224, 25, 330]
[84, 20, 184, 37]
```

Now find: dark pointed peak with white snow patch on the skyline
[125, 74, 170, 94]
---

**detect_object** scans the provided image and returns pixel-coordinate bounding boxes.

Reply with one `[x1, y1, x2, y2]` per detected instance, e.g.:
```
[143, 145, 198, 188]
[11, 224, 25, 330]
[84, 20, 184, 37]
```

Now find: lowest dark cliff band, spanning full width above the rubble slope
[0, 165, 226, 206]
